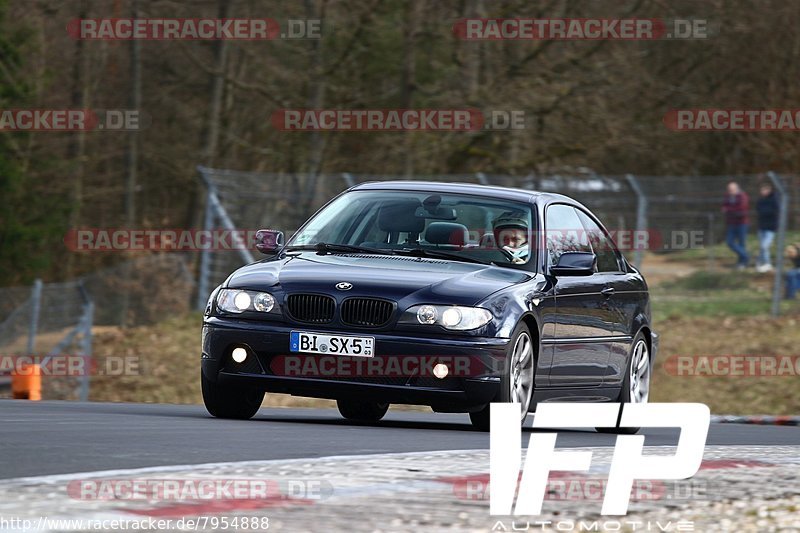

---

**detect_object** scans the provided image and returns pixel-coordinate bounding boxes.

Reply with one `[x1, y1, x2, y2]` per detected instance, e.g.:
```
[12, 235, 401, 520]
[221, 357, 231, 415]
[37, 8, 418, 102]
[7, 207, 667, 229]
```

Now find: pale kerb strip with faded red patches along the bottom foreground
[0, 446, 800, 532]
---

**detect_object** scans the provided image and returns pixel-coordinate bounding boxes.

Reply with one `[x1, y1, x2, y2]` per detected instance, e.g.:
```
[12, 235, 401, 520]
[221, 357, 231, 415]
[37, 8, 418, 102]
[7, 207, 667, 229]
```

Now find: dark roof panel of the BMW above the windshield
[350, 180, 580, 205]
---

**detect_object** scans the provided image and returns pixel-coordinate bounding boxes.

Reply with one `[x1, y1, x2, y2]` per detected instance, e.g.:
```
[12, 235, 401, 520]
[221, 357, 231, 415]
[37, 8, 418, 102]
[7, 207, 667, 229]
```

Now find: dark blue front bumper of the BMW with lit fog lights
[201, 317, 509, 412]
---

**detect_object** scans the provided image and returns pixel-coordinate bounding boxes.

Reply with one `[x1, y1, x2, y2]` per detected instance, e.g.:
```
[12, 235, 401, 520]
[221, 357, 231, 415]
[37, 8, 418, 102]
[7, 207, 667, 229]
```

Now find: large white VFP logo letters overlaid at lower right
[489, 403, 711, 515]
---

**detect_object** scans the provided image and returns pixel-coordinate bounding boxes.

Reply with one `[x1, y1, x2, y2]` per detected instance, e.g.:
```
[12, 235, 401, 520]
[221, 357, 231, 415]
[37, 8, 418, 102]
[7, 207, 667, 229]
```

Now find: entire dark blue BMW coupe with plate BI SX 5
[201, 181, 658, 432]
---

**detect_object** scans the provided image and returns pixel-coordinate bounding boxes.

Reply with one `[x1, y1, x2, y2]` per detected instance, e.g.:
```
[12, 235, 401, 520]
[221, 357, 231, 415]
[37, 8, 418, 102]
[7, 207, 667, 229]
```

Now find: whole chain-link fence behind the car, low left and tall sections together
[0, 167, 800, 399]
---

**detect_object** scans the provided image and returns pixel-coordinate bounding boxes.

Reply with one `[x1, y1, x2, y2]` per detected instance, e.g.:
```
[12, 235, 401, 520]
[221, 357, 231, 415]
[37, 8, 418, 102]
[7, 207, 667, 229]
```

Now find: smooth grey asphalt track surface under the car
[0, 400, 800, 479]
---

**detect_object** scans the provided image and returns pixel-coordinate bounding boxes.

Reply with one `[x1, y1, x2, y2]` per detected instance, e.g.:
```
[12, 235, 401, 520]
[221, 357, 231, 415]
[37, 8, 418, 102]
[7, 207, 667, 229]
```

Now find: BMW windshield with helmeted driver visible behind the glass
[288, 191, 535, 266]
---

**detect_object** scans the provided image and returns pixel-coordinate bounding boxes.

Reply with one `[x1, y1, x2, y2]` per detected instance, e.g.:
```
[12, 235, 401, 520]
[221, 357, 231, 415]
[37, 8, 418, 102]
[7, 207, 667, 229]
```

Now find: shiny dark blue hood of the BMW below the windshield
[225, 252, 531, 305]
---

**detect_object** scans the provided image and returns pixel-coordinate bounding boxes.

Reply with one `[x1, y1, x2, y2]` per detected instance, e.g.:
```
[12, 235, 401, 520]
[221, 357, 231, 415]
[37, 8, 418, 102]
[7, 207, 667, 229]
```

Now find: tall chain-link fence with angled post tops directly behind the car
[197, 167, 800, 309]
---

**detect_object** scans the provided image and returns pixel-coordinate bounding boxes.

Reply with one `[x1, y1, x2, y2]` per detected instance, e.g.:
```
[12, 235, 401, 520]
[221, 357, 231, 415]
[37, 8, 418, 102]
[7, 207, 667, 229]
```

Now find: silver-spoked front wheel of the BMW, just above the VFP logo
[469, 323, 537, 431]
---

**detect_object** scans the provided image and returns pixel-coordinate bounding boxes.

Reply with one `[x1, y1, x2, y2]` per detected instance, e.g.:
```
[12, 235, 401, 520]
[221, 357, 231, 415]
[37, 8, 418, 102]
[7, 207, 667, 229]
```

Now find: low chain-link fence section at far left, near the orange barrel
[0, 254, 195, 400]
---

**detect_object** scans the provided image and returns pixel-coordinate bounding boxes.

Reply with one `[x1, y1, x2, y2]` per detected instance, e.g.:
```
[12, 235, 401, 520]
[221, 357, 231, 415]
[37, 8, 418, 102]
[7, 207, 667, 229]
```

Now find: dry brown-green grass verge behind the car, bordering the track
[84, 251, 800, 415]
